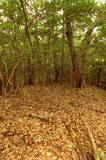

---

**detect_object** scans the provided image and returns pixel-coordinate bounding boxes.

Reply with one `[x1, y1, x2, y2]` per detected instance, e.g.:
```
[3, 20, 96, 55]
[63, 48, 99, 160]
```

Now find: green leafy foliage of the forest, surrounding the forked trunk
[0, 0, 106, 89]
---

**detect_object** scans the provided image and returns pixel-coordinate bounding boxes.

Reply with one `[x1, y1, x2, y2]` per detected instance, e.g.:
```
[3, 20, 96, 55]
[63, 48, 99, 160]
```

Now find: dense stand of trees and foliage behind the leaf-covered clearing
[0, 0, 106, 93]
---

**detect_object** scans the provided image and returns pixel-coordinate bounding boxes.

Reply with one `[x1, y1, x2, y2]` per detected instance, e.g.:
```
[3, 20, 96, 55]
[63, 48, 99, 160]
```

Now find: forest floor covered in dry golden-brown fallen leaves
[0, 86, 106, 160]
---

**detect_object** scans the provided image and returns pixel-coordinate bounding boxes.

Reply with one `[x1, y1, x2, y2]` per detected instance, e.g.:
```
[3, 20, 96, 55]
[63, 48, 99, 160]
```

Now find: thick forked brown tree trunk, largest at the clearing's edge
[63, 0, 100, 88]
